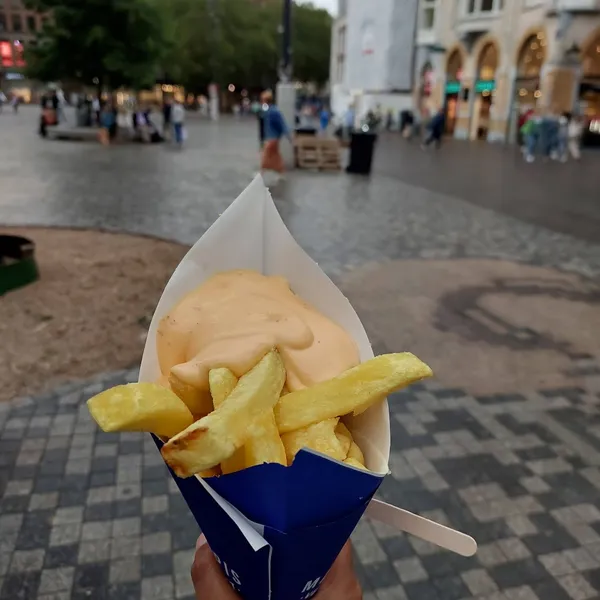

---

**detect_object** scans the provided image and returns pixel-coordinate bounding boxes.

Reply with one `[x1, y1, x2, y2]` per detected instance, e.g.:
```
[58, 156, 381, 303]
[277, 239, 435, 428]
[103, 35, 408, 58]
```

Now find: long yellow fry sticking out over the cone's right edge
[275, 352, 432, 434]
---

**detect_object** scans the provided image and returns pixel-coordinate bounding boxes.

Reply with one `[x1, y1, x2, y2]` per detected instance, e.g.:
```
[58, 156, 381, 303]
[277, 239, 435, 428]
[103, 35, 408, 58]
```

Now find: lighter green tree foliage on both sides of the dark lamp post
[159, 0, 331, 91]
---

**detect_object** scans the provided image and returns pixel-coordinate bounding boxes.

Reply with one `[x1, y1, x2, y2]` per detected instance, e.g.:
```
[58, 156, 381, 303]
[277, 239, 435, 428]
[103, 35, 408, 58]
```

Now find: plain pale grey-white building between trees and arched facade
[330, 0, 419, 120]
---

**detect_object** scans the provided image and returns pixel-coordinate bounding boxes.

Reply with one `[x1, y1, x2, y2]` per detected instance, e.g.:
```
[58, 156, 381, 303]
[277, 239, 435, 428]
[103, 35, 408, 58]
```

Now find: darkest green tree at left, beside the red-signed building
[27, 0, 166, 90]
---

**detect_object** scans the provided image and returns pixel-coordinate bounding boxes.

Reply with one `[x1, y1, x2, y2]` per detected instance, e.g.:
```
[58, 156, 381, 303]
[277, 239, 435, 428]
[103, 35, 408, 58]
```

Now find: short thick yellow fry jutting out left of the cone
[87, 383, 194, 438]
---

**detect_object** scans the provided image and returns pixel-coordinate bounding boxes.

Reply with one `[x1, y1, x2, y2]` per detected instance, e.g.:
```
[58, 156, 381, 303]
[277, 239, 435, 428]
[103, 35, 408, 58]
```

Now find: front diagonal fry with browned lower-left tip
[161, 350, 285, 477]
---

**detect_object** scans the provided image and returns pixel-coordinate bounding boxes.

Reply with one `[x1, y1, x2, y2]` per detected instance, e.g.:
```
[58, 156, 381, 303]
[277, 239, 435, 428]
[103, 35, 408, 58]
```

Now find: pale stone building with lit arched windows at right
[414, 0, 600, 141]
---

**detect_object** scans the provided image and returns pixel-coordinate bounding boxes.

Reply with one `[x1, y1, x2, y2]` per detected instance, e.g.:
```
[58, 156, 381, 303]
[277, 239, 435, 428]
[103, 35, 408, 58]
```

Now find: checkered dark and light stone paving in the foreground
[0, 349, 600, 600]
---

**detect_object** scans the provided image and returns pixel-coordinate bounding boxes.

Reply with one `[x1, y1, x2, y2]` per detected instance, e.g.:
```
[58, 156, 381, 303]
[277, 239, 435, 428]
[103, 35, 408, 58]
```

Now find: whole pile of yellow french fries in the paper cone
[88, 348, 432, 477]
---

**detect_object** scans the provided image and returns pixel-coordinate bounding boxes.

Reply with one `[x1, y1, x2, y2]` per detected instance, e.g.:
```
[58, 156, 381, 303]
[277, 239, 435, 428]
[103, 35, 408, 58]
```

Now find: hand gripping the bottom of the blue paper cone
[192, 535, 362, 600]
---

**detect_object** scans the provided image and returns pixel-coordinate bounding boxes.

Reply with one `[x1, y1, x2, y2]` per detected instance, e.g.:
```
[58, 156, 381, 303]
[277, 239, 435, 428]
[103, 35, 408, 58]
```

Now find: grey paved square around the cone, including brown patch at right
[0, 109, 600, 600]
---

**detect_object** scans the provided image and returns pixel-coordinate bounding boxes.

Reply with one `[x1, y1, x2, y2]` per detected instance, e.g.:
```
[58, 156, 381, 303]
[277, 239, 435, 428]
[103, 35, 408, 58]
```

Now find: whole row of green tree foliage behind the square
[27, 0, 331, 92]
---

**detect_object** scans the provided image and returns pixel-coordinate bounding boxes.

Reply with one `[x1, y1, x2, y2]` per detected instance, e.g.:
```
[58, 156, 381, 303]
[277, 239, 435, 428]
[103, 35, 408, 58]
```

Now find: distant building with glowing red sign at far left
[0, 0, 44, 102]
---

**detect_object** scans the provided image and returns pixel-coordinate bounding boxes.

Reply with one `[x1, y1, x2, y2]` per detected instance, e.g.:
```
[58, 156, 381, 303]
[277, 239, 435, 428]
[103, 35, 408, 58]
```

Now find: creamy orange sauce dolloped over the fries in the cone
[156, 271, 359, 391]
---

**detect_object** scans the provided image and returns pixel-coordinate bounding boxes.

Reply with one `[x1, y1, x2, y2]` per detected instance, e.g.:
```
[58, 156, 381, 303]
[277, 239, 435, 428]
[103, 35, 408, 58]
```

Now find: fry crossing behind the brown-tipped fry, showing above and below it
[208, 368, 287, 475]
